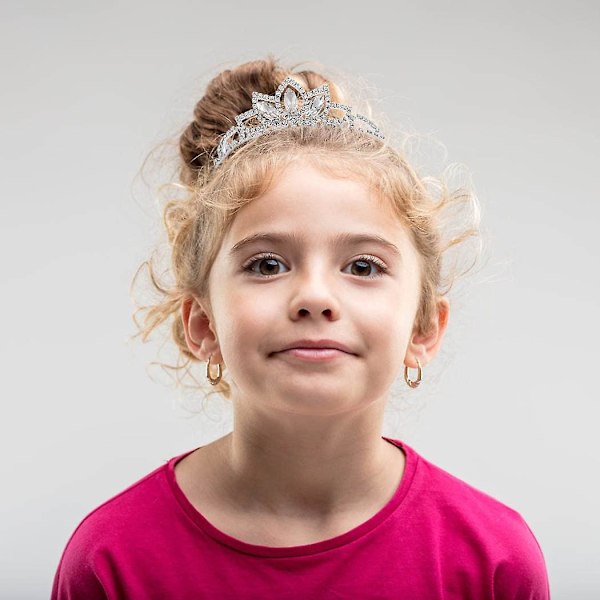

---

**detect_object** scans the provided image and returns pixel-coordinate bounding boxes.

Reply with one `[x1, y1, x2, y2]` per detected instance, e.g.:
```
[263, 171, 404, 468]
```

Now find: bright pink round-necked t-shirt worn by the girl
[52, 438, 550, 600]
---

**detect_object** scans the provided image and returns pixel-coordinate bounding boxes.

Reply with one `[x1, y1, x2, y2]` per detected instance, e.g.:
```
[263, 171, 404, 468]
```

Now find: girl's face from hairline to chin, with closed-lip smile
[198, 161, 424, 415]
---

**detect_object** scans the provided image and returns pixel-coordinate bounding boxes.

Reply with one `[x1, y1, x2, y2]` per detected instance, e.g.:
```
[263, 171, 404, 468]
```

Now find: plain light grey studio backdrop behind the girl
[0, 0, 600, 599]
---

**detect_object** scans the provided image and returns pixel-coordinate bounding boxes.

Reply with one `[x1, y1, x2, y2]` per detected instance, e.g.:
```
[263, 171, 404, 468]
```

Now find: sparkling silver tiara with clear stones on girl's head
[214, 77, 384, 167]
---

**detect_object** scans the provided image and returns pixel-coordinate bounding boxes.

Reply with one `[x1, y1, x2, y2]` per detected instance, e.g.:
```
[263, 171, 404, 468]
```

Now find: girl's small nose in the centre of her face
[289, 270, 340, 321]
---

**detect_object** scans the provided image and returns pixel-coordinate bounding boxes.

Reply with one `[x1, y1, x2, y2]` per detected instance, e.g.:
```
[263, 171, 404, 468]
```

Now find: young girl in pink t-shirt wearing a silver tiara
[52, 58, 550, 600]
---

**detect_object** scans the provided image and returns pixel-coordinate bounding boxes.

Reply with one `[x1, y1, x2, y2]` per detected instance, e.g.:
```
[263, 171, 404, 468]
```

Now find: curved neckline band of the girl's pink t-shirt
[166, 436, 418, 557]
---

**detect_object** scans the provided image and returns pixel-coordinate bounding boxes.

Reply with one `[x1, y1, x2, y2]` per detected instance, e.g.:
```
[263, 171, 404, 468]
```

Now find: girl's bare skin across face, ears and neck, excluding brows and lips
[176, 160, 449, 546]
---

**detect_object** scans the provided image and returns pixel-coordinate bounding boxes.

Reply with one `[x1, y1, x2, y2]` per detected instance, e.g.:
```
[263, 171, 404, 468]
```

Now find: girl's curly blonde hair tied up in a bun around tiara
[132, 57, 479, 398]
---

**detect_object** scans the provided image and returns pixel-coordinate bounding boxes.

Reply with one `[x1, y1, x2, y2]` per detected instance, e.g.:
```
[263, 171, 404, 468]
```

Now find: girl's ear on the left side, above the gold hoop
[181, 296, 224, 365]
